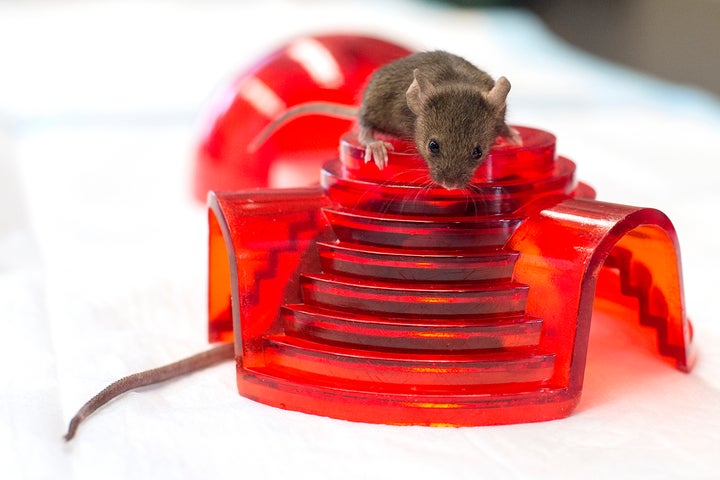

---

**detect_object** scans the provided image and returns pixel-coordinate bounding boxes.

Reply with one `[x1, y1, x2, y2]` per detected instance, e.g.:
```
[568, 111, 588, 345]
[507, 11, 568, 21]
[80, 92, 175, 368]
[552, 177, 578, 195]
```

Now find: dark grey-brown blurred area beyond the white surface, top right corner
[438, 0, 720, 95]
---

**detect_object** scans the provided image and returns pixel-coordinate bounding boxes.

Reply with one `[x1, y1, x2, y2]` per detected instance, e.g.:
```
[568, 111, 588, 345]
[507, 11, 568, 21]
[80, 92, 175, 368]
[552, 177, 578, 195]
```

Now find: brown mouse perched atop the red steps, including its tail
[248, 50, 522, 190]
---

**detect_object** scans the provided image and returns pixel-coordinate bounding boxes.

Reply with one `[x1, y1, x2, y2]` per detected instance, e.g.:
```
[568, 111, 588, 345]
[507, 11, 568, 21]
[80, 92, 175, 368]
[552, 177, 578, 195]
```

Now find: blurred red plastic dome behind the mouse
[194, 35, 410, 201]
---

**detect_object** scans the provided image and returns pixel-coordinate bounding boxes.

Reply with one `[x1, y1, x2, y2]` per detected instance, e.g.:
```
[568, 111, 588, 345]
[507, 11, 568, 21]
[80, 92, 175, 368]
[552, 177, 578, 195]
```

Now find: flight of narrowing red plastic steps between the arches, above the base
[256, 201, 554, 392]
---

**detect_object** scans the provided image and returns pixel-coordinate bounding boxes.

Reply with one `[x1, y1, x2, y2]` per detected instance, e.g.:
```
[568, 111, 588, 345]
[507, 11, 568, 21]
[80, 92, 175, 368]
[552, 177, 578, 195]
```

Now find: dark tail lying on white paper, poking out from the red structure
[64, 343, 235, 441]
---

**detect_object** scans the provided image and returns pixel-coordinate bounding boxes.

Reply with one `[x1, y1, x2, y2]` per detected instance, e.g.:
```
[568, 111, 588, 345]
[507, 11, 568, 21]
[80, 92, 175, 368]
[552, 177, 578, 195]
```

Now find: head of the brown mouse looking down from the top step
[406, 69, 510, 190]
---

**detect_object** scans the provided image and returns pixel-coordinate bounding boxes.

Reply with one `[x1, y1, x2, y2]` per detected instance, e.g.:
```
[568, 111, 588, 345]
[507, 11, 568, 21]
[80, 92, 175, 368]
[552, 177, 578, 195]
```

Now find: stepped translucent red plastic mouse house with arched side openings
[200, 35, 693, 425]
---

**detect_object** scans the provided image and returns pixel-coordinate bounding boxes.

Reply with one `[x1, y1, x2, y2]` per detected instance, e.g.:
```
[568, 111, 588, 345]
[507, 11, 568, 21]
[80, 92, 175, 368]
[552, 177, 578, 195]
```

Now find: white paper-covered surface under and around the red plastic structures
[0, 1, 720, 479]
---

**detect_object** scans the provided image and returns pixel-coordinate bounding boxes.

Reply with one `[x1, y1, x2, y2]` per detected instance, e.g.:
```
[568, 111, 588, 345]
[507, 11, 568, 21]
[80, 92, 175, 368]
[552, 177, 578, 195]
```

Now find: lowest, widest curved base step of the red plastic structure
[238, 367, 579, 426]
